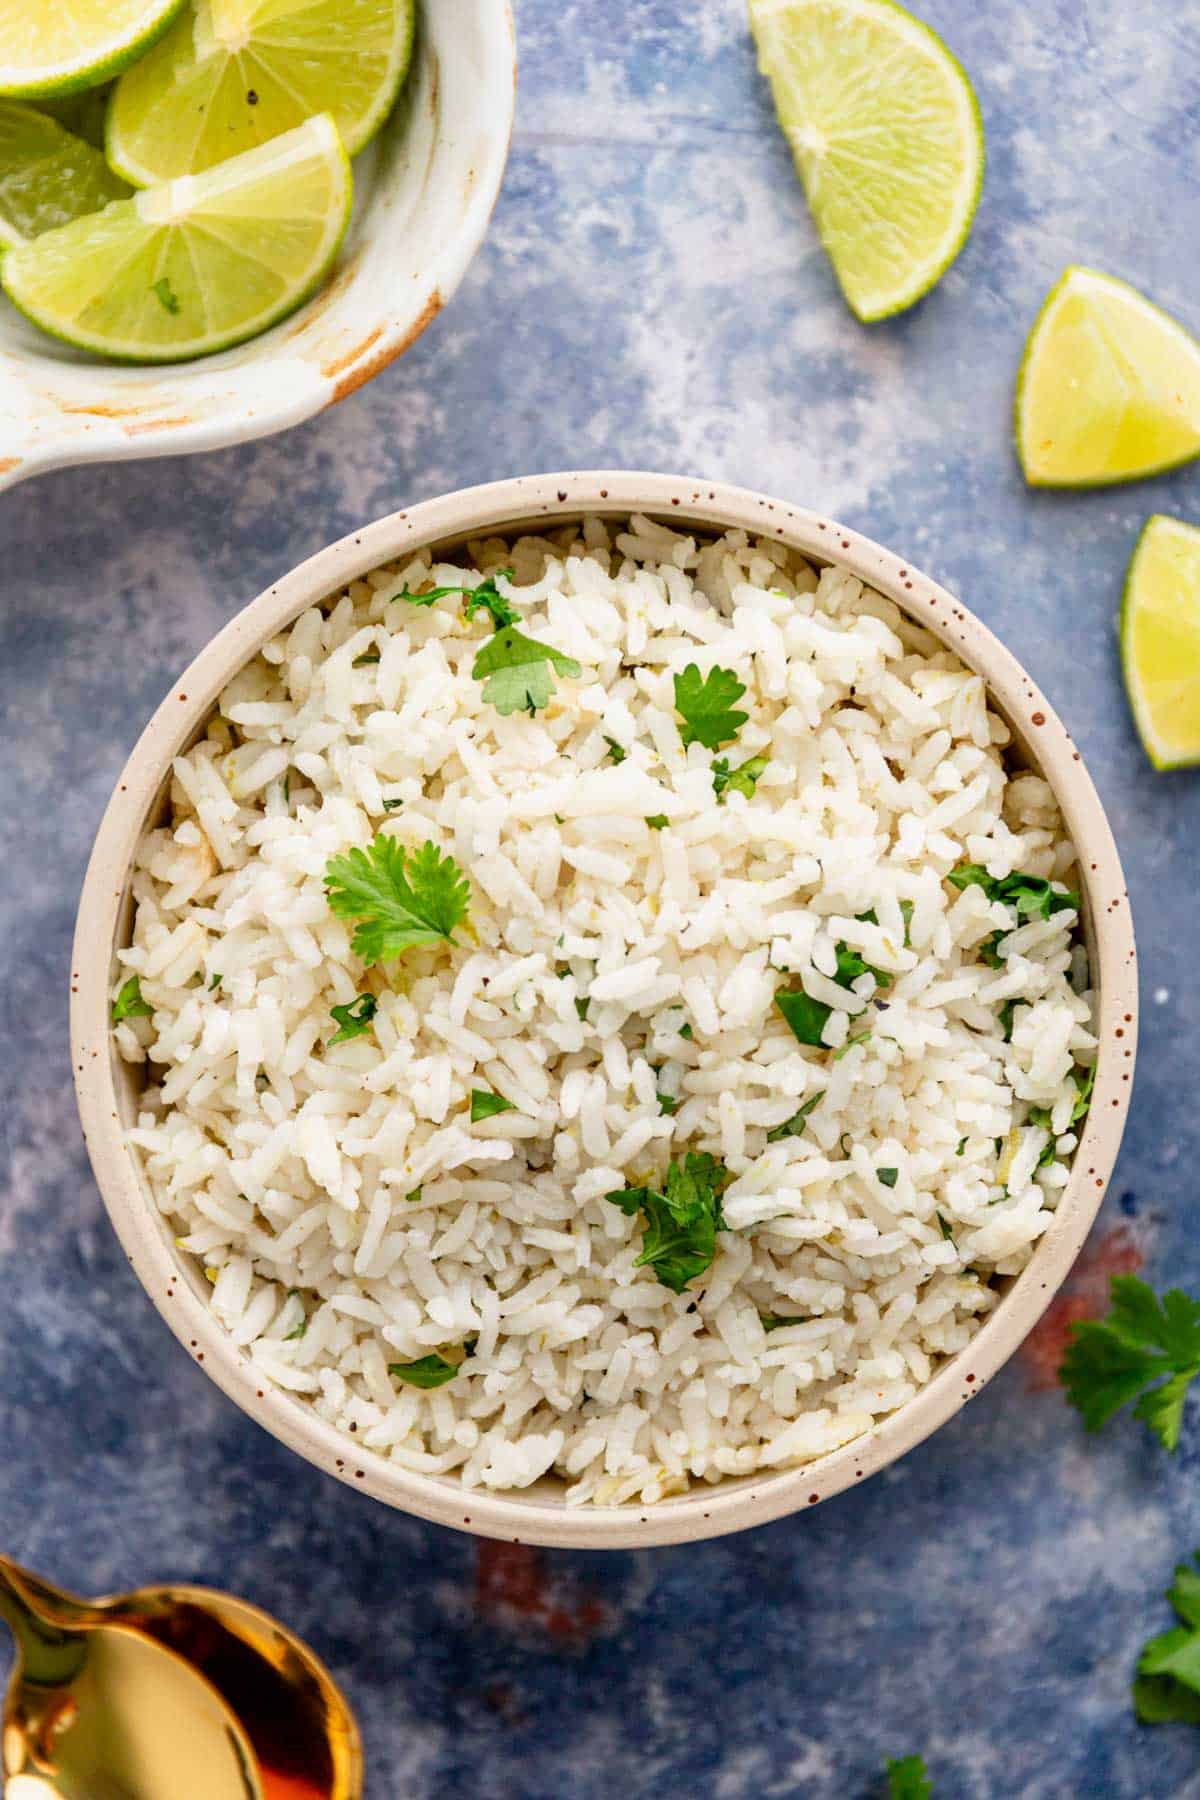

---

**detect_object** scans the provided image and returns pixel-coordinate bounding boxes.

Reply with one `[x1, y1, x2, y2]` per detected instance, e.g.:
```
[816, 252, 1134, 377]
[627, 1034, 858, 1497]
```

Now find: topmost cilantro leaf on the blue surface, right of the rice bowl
[1058, 1274, 1200, 1451]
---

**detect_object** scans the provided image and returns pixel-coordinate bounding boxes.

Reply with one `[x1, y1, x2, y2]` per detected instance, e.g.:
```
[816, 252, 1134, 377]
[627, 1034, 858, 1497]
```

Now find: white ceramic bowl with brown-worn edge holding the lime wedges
[0, 0, 516, 488]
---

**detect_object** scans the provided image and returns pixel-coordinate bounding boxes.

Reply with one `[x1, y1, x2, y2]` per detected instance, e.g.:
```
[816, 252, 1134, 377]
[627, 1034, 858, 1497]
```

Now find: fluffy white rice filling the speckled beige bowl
[113, 518, 1096, 1503]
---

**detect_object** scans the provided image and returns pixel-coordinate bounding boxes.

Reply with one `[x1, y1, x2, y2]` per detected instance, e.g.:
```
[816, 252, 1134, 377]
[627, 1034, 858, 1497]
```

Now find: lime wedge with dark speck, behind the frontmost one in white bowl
[106, 0, 412, 187]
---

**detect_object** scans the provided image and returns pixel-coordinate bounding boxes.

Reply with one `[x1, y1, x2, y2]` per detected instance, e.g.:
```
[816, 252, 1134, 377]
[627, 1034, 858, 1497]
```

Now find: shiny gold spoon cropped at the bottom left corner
[0, 1557, 362, 1800]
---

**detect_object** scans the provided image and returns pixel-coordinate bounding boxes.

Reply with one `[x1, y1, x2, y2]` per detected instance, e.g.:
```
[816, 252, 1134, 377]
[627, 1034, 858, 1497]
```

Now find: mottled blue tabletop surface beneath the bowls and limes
[0, 0, 1200, 1800]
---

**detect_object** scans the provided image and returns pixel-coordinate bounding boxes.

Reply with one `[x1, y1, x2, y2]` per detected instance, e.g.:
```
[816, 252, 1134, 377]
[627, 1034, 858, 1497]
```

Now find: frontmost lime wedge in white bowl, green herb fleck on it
[0, 113, 353, 362]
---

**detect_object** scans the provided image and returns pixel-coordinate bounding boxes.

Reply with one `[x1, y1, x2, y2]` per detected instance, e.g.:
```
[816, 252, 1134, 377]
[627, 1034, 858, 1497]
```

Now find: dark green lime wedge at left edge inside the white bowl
[0, 101, 130, 248]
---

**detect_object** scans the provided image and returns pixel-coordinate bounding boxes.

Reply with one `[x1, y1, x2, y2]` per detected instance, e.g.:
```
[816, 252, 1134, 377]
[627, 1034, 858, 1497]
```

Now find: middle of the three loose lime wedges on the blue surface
[1016, 268, 1200, 488]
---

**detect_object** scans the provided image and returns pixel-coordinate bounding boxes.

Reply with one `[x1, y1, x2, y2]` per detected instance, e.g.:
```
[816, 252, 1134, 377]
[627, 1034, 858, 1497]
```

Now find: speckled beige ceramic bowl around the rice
[72, 473, 1137, 1546]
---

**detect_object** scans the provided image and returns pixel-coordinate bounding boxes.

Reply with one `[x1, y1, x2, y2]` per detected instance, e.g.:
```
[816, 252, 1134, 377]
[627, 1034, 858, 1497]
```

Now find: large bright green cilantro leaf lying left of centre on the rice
[326, 837, 471, 963]
